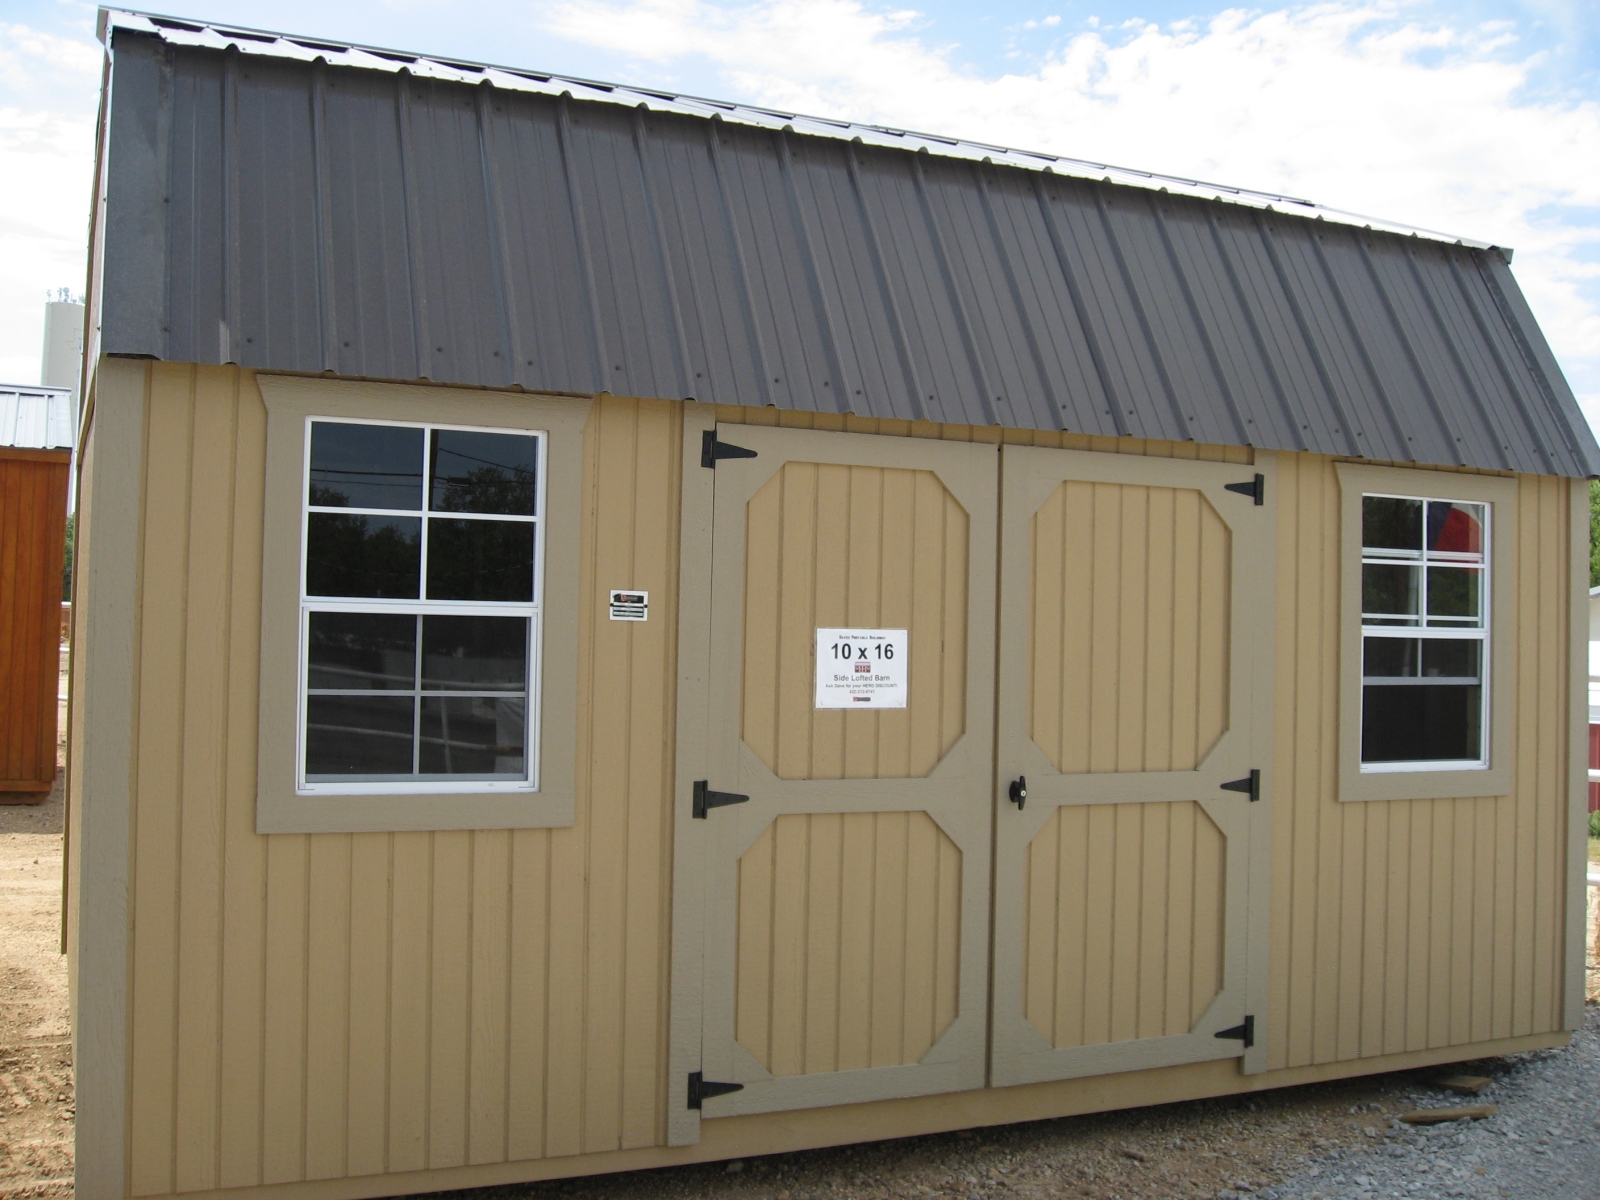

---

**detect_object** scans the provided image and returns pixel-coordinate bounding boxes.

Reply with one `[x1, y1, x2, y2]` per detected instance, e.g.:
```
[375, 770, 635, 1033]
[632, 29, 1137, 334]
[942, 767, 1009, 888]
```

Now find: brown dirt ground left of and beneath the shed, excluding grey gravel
[0, 649, 1600, 1200]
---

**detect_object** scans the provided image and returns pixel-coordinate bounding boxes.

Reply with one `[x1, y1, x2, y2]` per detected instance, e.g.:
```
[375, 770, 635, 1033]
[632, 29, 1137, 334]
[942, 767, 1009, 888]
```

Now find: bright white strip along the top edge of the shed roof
[96, 8, 1512, 261]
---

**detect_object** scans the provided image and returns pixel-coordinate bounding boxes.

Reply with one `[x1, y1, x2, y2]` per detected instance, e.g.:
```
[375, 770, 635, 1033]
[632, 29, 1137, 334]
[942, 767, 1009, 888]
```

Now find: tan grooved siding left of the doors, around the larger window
[120, 374, 680, 1195]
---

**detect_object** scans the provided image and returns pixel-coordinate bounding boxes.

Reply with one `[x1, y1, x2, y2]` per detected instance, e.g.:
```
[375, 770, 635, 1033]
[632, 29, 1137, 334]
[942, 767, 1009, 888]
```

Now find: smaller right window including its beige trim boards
[1333, 462, 1518, 800]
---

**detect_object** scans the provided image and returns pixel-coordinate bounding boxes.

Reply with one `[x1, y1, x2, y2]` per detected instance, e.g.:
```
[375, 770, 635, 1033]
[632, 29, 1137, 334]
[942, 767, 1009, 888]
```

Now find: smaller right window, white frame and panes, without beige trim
[1362, 494, 1490, 771]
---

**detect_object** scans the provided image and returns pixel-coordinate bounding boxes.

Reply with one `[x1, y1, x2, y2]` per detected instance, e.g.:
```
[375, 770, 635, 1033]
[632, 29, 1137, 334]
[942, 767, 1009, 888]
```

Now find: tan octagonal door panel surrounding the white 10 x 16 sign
[742, 462, 970, 779]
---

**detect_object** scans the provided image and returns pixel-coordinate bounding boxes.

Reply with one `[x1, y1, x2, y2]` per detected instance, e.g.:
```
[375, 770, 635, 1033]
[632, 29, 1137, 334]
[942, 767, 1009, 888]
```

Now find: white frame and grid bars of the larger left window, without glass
[294, 414, 550, 795]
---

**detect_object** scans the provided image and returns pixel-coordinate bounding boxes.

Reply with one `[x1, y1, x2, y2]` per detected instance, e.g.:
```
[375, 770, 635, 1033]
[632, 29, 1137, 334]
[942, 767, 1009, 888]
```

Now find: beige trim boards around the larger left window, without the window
[256, 374, 592, 834]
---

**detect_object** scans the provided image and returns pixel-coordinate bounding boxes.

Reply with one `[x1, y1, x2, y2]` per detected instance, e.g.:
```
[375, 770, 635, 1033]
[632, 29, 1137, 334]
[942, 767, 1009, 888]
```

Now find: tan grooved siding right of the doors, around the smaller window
[1267, 454, 1582, 1067]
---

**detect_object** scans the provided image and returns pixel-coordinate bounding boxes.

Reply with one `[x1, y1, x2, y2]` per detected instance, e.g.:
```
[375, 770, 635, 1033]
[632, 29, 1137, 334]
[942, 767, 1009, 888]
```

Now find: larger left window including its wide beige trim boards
[256, 374, 592, 834]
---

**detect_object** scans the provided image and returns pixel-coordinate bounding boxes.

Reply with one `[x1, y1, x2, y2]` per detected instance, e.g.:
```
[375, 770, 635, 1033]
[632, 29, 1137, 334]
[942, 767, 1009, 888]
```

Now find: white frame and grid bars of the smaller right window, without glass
[1362, 492, 1494, 773]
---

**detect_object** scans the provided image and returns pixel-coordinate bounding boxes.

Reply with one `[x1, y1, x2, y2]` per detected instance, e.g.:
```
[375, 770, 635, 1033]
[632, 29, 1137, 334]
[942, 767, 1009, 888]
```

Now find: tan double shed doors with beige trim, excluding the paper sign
[669, 426, 1270, 1144]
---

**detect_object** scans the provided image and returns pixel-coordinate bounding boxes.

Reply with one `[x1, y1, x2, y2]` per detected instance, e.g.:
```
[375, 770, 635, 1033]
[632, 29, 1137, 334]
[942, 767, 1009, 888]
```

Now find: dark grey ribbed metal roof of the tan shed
[101, 13, 1600, 475]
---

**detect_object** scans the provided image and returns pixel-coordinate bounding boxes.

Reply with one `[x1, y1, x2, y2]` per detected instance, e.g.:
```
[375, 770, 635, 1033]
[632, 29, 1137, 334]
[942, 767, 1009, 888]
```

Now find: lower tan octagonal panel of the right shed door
[1022, 802, 1224, 1050]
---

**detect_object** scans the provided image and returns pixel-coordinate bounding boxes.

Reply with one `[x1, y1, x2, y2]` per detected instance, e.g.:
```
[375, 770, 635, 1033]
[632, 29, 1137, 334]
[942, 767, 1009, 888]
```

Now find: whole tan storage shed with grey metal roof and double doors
[67, 11, 1600, 1200]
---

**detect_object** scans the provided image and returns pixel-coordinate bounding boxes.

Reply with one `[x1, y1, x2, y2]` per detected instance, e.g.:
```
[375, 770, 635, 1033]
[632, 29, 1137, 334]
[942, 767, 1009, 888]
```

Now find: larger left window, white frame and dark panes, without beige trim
[299, 419, 544, 792]
